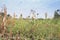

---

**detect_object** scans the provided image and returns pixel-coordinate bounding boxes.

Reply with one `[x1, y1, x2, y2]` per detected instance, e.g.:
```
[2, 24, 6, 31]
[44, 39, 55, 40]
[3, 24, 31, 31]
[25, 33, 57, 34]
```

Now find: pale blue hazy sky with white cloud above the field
[0, 0, 60, 18]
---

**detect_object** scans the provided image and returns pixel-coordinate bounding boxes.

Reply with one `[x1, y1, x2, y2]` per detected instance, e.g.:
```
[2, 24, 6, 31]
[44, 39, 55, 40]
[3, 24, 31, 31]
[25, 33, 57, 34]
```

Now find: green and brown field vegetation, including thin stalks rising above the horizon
[0, 6, 60, 40]
